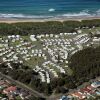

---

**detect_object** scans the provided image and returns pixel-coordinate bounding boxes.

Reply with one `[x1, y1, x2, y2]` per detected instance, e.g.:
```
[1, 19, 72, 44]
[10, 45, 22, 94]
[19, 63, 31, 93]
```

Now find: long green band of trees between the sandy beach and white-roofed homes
[0, 19, 100, 35]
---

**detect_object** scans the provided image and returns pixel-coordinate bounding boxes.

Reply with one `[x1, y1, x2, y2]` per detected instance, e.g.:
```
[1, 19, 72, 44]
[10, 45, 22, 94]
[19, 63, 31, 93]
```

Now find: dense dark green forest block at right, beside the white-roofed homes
[69, 47, 100, 86]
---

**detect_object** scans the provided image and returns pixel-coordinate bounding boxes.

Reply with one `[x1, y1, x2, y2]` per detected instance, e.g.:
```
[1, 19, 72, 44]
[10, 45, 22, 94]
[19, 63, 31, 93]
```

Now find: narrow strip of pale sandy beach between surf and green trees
[0, 16, 100, 24]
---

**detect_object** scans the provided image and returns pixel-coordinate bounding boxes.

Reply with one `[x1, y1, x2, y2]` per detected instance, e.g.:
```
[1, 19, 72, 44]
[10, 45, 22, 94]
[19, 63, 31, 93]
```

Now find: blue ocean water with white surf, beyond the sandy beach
[0, 0, 100, 18]
